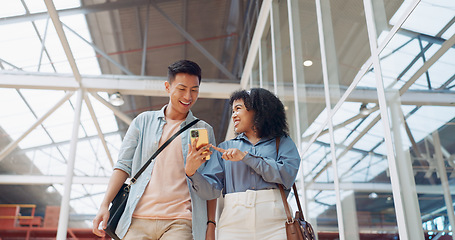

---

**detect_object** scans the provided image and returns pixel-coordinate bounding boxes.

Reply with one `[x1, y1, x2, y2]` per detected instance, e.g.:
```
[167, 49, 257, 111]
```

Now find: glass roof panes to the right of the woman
[303, 0, 455, 218]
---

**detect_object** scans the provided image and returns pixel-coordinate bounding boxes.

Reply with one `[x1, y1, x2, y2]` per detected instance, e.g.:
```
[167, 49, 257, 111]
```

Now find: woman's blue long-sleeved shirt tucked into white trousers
[188, 134, 300, 200]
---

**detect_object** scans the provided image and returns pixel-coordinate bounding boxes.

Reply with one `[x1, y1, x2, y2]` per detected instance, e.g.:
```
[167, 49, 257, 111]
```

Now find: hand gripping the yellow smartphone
[185, 138, 212, 177]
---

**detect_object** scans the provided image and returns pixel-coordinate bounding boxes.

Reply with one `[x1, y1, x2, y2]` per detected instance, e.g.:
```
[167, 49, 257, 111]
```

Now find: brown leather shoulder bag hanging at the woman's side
[276, 138, 316, 240]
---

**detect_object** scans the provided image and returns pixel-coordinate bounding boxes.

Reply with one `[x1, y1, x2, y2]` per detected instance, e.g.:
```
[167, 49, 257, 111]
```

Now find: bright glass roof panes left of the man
[0, 0, 121, 222]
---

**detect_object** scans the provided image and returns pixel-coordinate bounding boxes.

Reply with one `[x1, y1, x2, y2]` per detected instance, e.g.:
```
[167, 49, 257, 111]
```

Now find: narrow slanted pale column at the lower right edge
[432, 130, 455, 240]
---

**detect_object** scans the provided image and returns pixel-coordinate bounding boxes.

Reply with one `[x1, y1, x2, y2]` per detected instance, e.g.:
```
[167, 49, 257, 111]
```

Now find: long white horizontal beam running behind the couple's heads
[0, 71, 455, 106]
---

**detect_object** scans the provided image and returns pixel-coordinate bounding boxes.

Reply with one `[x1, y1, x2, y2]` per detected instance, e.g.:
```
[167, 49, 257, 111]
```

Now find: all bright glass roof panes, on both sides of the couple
[0, 0, 455, 231]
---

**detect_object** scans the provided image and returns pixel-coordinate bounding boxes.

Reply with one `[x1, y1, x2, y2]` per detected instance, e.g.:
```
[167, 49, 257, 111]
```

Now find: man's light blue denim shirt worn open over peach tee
[114, 106, 216, 240]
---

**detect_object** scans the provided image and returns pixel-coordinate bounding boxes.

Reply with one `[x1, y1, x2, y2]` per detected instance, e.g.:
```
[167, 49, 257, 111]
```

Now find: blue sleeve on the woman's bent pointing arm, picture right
[242, 137, 300, 189]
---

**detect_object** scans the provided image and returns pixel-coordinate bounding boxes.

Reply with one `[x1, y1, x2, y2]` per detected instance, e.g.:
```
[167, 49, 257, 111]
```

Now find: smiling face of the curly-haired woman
[232, 99, 256, 138]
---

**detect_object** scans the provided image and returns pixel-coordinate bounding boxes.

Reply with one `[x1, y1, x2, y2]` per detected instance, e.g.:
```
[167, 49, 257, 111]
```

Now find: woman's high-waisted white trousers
[217, 189, 286, 240]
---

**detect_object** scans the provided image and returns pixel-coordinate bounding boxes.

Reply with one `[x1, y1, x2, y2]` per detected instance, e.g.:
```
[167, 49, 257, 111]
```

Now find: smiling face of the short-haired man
[164, 73, 199, 120]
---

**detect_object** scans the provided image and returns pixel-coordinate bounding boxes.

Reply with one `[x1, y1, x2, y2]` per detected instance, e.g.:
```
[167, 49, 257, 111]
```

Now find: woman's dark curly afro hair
[229, 88, 289, 138]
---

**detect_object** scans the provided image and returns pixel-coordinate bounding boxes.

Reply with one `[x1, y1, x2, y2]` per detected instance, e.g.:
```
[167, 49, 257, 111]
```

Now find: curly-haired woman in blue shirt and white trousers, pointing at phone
[185, 88, 300, 239]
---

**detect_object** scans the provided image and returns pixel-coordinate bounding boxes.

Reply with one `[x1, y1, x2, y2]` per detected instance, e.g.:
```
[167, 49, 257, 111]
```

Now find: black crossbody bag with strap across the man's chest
[104, 119, 199, 240]
